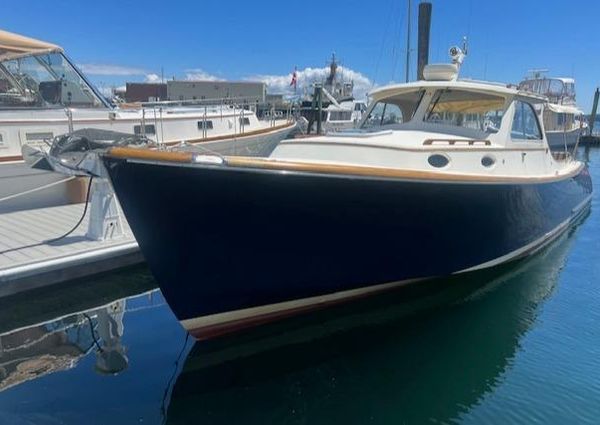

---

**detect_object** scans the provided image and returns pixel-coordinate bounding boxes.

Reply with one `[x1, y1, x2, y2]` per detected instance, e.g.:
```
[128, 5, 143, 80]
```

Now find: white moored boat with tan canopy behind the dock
[0, 30, 295, 213]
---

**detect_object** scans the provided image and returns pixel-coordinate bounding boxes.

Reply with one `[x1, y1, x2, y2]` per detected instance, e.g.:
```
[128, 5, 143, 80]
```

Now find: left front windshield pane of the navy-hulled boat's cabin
[361, 90, 425, 128]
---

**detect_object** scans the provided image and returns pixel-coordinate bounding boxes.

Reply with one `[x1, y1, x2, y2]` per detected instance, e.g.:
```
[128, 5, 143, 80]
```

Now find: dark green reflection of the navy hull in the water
[167, 219, 584, 424]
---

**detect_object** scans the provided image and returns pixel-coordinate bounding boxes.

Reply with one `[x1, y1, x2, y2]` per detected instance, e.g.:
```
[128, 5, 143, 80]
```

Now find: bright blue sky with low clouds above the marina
[0, 0, 600, 112]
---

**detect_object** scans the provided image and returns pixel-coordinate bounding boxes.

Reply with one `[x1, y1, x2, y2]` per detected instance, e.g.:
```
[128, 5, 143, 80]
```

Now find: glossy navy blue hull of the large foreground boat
[104, 157, 592, 338]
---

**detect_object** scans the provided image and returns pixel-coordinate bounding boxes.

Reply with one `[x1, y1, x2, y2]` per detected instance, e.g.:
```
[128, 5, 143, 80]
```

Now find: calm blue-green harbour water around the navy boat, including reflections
[0, 150, 600, 424]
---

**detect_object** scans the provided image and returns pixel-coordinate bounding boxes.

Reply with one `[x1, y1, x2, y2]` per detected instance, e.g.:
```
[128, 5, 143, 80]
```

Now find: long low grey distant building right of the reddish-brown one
[167, 80, 267, 103]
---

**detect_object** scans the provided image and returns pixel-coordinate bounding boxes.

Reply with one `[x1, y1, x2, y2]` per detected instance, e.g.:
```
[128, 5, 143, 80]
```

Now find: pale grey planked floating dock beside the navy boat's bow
[0, 204, 143, 296]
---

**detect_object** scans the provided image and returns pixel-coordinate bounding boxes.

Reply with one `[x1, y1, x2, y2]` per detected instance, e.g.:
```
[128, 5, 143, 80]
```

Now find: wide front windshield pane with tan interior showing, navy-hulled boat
[425, 89, 505, 133]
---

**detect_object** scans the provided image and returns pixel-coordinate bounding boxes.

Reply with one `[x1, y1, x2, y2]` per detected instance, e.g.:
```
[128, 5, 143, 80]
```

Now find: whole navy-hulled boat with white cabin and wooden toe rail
[98, 49, 592, 339]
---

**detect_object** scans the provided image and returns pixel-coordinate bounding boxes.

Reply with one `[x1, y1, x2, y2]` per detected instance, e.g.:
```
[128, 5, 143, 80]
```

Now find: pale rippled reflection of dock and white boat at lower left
[0, 291, 155, 391]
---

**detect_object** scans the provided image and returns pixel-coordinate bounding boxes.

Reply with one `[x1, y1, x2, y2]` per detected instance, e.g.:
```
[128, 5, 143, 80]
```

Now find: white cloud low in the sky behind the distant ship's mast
[245, 66, 375, 99]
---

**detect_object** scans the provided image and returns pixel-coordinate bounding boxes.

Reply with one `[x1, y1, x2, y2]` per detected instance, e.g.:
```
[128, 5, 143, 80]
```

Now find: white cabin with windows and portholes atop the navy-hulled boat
[271, 77, 577, 176]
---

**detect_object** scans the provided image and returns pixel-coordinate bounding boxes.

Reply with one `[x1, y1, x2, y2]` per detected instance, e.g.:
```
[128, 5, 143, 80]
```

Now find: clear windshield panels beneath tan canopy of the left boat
[0, 53, 104, 108]
